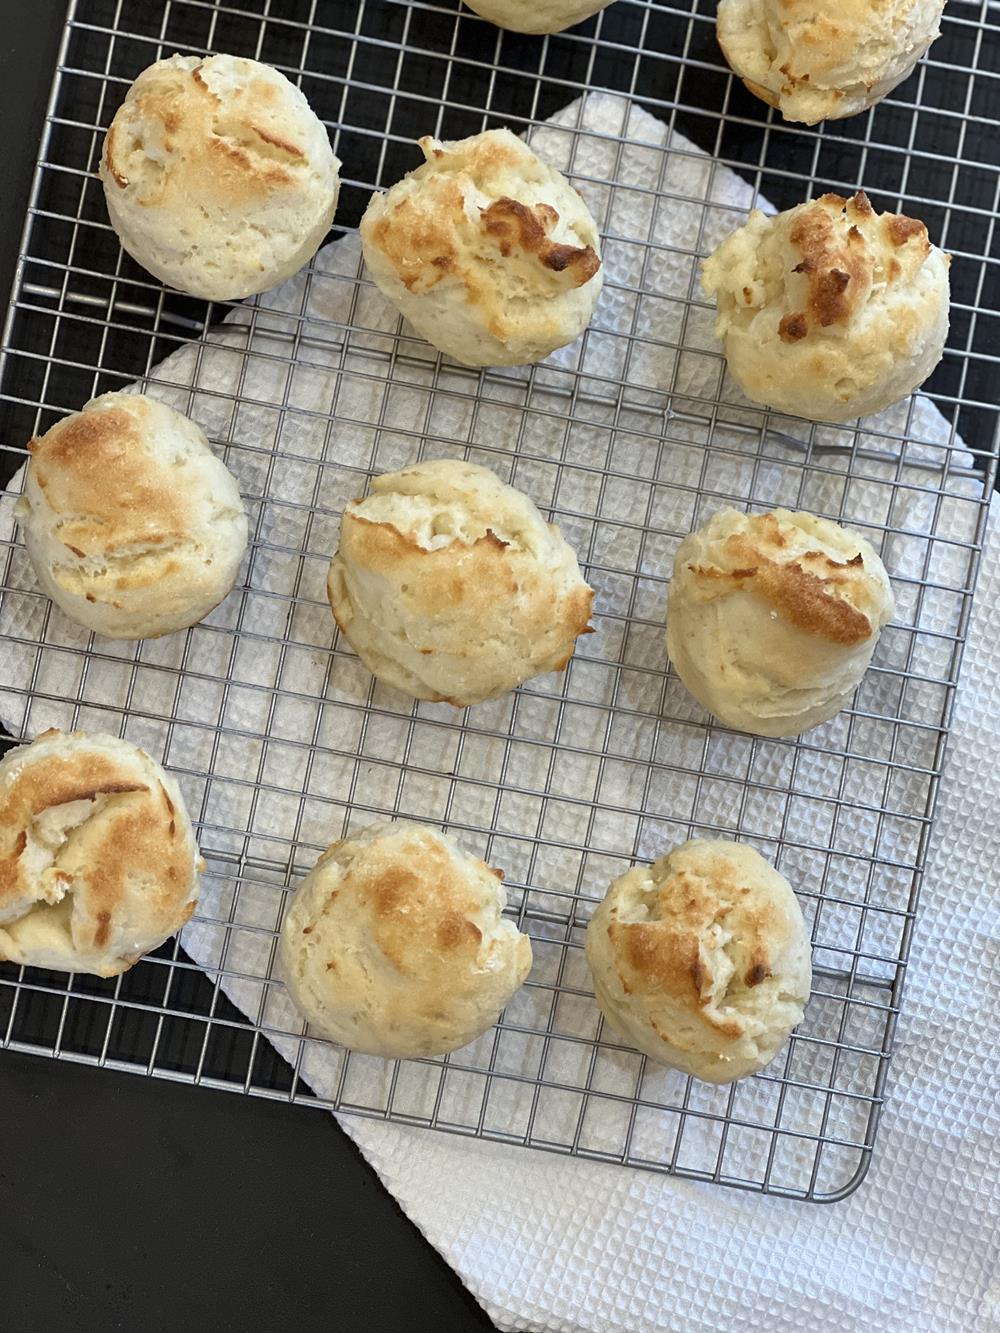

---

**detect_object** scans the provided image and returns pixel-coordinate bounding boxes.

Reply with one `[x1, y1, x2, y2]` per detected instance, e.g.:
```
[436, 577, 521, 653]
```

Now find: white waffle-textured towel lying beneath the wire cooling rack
[0, 96, 997, 1330]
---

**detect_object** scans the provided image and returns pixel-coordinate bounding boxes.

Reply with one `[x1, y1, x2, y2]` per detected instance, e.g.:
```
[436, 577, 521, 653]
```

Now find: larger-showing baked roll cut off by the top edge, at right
[716, 0, 944, 125]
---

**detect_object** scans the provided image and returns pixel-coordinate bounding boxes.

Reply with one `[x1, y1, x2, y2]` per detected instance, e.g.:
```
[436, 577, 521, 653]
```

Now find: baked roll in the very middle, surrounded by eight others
[327, 459, 593, 708]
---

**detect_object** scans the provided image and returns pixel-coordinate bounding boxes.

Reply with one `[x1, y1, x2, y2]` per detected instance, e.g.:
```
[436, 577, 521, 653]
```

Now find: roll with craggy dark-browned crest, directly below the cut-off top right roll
[701, 191, 951, 421]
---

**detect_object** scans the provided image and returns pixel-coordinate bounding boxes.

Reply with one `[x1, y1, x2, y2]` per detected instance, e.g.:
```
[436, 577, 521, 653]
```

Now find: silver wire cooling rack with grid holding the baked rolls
[0, 0, 1000, 1200]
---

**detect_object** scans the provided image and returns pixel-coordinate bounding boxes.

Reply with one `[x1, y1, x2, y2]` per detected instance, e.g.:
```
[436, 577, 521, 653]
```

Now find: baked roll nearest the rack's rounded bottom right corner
[587, 840, 812, 1082]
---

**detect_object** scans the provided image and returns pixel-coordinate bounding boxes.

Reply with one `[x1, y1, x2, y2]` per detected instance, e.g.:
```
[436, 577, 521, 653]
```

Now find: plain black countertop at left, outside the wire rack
[0, 0, 493, 1333]
